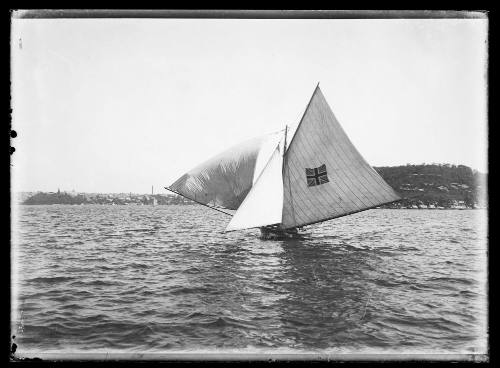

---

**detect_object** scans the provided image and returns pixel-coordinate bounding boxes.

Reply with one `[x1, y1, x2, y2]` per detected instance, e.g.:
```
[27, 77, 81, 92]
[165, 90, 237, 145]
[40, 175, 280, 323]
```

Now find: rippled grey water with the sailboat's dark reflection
[12, 205, 487, 355]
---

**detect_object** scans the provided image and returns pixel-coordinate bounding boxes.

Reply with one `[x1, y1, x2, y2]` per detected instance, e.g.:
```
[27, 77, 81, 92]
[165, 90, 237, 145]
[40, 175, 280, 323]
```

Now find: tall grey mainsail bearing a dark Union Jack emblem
[282, 87, 400, 229]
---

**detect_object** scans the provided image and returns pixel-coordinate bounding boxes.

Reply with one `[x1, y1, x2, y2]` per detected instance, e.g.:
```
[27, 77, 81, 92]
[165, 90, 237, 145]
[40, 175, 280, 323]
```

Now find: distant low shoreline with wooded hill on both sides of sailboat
[15, 164, 488, 209]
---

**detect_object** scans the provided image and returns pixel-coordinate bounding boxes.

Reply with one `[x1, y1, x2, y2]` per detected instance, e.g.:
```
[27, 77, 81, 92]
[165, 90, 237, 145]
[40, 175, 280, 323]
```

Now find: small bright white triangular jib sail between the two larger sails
[226, 145, 283, 231]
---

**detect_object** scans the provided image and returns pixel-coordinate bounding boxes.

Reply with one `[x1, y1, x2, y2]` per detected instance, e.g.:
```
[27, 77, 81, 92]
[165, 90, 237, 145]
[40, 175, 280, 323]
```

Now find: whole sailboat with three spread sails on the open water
[165, 83, 401, 239]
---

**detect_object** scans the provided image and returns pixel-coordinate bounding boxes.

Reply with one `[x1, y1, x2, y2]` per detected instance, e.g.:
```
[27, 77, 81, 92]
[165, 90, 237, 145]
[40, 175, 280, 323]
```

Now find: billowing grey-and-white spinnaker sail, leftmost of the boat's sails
[168, 133, 282, 210]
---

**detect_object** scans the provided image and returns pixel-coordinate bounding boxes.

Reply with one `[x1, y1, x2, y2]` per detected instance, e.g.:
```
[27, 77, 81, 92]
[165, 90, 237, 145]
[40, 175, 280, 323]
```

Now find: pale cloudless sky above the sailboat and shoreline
[11, 19, 487, 193]
